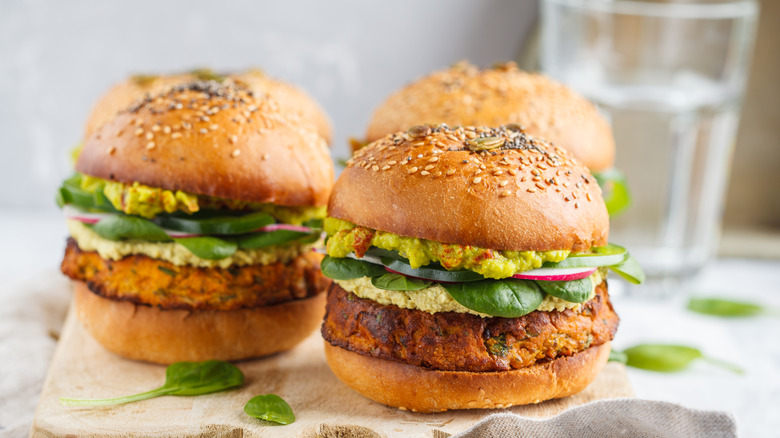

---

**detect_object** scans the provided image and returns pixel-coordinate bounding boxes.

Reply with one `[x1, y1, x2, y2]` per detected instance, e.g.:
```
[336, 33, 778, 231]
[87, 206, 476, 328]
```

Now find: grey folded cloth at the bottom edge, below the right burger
[450, 398, 737, 438]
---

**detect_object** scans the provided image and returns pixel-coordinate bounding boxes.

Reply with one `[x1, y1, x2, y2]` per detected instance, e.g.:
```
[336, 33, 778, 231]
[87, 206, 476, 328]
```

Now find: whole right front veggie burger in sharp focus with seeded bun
[322, 125, 643, 412]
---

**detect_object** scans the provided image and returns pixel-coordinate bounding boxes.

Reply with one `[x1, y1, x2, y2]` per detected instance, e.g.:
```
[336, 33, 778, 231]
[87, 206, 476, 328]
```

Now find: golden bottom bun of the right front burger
[325, 342, 611, 412]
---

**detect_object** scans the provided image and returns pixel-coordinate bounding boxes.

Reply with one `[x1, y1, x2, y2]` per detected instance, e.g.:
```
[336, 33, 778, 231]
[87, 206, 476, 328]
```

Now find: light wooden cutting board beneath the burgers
[31, 302, 634, 438]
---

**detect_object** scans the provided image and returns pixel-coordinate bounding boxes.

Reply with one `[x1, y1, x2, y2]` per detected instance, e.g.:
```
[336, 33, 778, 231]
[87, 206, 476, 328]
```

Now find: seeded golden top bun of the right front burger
[328, 126, 609, 251]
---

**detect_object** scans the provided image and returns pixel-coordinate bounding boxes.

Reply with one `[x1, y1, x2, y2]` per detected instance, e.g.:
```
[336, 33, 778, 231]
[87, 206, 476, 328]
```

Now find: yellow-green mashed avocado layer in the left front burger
[81, 175, 326, 225]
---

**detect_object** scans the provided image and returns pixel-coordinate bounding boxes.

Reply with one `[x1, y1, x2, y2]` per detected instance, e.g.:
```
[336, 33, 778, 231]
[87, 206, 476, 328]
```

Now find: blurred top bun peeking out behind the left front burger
[86, 70, 333, 143]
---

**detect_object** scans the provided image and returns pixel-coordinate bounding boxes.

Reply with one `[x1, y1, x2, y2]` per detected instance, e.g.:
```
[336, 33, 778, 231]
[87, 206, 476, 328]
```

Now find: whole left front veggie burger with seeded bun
[58, 79, 333, 363]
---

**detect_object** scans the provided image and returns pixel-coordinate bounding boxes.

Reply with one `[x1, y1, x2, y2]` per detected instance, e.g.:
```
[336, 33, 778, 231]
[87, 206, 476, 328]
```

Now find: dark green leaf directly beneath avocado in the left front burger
[154, 212, 274, 235]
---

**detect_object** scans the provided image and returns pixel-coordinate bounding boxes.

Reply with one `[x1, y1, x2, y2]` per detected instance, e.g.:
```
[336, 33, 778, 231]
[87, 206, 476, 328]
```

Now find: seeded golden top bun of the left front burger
[76, 81, 333, 206]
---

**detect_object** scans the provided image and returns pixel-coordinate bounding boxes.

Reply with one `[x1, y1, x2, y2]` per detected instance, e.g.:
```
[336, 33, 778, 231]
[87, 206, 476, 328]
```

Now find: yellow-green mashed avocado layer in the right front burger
[324, 217, 569, 279]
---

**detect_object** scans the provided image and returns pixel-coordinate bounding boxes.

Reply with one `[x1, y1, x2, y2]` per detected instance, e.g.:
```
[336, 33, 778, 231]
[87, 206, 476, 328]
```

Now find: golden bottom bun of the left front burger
[73, 281, 325, 364]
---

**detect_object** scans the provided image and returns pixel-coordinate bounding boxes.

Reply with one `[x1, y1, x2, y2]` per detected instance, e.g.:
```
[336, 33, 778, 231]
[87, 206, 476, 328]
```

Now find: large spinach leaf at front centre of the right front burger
[441, 278, 545, 318]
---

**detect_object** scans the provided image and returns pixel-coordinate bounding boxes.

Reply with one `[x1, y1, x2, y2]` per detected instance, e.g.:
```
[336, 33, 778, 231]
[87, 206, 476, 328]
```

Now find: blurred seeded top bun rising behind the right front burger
[366, 62, 615, 170]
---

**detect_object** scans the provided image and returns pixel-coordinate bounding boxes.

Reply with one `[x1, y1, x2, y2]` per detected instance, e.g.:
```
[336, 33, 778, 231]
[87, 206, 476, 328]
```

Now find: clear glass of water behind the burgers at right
[540, 0, 758, 294]
